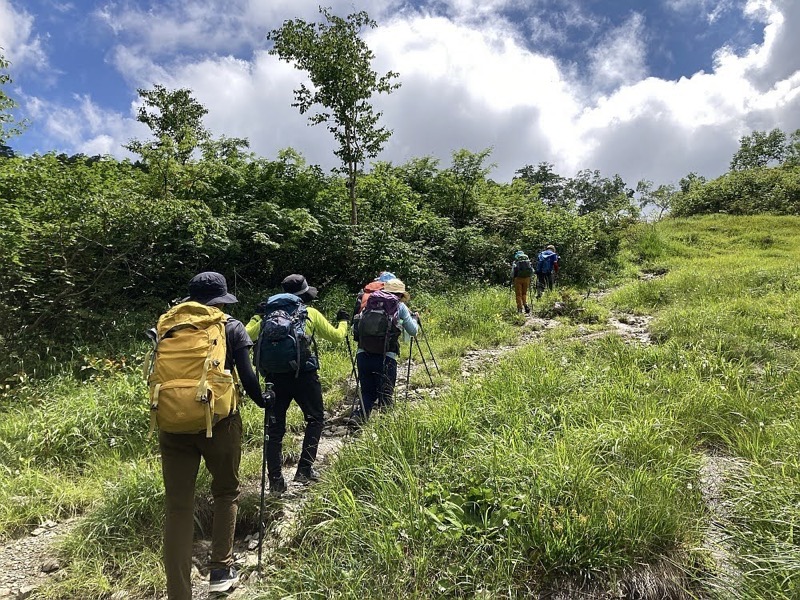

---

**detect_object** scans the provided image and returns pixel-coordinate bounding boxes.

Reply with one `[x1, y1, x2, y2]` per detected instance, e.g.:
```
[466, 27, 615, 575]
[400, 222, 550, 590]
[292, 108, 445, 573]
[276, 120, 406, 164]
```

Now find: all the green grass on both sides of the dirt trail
[6, 216, 800, 599]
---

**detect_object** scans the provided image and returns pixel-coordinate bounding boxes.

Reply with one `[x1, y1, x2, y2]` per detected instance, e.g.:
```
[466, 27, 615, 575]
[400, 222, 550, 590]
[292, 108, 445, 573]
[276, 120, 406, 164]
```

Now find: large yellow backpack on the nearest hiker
[145, 302, 239, 437]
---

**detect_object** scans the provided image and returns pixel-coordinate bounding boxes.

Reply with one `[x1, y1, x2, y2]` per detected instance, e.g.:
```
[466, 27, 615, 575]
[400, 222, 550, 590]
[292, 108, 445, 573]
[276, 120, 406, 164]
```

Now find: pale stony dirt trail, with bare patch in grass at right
[0, 276, 730, 600]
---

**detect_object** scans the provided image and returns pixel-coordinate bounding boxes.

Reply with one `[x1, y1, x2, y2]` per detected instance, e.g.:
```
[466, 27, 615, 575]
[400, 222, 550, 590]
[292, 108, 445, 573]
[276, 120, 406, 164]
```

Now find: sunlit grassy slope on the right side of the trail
[255, 217, 800, 598]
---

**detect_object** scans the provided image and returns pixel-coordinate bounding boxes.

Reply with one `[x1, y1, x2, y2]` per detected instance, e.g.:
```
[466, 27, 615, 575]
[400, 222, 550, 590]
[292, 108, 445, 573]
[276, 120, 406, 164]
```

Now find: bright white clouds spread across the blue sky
[10, 0, 800, 190]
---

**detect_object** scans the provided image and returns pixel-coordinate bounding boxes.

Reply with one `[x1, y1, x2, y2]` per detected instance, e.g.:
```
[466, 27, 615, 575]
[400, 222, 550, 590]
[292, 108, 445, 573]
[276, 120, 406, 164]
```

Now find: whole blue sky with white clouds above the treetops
[0, 0, 800, 187]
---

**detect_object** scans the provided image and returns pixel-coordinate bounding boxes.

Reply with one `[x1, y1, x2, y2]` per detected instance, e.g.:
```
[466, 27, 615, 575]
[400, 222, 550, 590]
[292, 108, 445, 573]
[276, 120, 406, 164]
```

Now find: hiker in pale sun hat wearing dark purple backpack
[350, 279, 419, 426]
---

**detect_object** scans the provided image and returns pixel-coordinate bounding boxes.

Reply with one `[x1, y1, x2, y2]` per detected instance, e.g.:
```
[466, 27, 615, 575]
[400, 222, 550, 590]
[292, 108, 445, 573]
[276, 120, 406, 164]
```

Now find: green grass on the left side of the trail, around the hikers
[0, 289, 536, 598]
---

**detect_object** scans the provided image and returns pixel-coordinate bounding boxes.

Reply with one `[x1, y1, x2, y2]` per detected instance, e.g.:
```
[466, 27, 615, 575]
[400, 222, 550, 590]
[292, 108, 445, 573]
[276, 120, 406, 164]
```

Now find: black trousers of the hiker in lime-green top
[267, 371, 325, 479]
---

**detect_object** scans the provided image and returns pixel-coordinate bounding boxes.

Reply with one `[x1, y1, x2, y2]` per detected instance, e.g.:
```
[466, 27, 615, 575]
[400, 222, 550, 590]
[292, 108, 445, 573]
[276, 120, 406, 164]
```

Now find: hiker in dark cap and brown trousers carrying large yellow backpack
[148, 271, 264, 600]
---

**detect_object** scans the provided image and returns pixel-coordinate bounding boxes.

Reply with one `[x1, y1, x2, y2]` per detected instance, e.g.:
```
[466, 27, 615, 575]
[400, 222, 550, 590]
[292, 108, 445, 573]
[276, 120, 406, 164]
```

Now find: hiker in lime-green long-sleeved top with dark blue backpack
[247, 274, 349, 496]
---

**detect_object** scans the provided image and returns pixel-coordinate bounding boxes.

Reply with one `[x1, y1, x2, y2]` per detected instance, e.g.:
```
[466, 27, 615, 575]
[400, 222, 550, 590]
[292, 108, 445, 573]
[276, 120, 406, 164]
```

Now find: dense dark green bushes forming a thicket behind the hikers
[0, 148, 633, 378]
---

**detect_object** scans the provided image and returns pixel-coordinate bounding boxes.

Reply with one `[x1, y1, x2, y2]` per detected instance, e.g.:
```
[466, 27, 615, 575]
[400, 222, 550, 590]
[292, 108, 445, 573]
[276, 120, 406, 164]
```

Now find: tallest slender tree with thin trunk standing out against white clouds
[267, 7, 400, 225]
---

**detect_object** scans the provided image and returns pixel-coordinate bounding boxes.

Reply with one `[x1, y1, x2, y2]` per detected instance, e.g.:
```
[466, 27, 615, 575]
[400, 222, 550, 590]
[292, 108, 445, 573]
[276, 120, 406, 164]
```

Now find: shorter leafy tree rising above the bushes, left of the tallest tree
[125, 84, 209, 165]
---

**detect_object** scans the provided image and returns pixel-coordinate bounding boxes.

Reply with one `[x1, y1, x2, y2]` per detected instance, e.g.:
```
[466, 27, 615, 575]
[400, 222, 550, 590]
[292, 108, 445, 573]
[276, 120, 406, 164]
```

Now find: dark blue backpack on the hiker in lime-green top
[253, 294, 319, 377]
